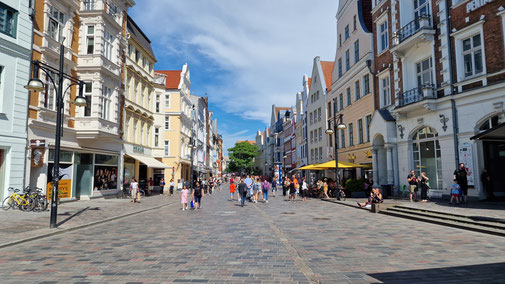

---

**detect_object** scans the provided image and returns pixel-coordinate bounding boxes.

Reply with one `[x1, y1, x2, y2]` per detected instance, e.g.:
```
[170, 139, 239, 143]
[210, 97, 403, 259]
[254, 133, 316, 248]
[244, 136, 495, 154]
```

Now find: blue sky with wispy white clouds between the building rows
[129, 0, 338, 153]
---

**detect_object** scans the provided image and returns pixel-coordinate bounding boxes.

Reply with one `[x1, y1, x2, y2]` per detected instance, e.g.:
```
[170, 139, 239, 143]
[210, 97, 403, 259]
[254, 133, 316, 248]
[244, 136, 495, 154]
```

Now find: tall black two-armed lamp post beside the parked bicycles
[25, 43, 87, 228]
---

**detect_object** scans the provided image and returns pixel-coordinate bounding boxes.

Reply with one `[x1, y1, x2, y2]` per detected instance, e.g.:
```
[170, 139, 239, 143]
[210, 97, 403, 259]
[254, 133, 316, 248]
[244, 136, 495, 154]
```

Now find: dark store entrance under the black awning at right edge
[483, 141, 505, 199]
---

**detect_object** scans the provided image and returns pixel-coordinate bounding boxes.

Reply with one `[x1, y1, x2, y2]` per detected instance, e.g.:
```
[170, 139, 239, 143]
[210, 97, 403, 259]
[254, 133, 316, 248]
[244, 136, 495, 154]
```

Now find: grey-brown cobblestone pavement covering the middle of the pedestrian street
[0, 185, 505, 283]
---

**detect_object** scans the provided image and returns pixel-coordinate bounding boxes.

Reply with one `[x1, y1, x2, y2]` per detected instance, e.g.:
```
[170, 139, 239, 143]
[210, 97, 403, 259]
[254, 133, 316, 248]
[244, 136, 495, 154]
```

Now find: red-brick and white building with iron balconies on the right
[366, 0, 505, 198]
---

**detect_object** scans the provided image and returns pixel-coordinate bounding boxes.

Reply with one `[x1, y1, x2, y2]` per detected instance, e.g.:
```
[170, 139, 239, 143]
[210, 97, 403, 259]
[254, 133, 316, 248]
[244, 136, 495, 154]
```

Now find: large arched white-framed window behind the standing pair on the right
[412, 126, 443, 189]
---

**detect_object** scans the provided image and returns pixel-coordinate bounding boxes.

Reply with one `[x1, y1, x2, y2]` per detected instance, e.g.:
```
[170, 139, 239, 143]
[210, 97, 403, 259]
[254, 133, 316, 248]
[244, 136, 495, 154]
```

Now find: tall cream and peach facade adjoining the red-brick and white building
[326, 0, 375, 181]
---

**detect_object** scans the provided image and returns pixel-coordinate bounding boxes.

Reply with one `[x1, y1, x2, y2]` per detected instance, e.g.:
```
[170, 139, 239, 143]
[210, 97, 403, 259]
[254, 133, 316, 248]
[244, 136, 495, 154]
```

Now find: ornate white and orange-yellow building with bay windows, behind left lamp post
[26, 0, 135, 199]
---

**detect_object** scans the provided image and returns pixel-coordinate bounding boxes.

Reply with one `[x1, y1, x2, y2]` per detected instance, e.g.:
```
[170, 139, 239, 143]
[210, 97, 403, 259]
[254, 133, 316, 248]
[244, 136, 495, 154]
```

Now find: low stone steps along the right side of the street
[379, 207, 505, 237]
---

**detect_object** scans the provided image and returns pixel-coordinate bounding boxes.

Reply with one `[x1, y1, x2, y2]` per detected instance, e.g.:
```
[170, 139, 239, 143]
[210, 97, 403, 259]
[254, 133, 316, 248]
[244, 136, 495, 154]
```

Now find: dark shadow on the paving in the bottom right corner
[368, 262, 505, 284]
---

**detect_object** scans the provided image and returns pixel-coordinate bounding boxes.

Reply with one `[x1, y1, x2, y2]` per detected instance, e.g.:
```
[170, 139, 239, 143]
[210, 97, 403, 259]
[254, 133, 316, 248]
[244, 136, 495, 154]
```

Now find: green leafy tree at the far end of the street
[227, 142, 258, 174]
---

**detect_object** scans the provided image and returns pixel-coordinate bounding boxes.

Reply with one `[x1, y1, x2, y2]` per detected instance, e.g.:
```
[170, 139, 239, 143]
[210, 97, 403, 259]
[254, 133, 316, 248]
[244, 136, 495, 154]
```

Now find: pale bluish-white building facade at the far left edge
[0, 0, 32, 200]
